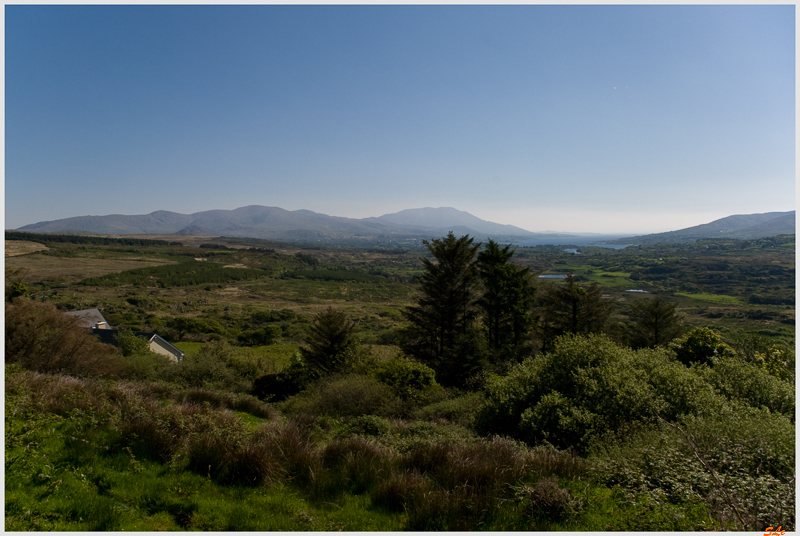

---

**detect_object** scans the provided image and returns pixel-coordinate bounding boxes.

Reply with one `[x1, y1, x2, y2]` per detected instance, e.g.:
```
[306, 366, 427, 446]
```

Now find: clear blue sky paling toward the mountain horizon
[5, 5, 795, 233]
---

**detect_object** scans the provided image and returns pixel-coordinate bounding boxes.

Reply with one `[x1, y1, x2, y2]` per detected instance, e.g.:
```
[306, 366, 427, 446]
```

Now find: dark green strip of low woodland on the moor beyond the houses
[81, 261, 269, 288]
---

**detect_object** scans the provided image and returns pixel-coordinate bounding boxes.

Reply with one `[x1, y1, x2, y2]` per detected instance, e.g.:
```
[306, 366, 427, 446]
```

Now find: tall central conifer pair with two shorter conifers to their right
[403, 232, 682, 386]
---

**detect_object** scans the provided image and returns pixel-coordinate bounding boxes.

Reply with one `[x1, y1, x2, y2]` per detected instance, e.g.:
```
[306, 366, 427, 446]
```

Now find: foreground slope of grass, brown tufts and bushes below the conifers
[5, 300, 795, 531]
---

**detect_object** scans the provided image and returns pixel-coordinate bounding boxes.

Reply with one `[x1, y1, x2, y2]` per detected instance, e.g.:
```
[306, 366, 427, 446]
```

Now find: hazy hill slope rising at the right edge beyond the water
[613, 210, 795, 244]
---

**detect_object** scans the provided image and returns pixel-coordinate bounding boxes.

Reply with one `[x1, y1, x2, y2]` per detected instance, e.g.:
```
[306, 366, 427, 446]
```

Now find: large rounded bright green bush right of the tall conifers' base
[478, 335, 724, 450]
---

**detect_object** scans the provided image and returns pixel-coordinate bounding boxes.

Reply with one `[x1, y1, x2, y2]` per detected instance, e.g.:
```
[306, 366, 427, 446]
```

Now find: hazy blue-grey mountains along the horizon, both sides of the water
[12, 205, 795, 244]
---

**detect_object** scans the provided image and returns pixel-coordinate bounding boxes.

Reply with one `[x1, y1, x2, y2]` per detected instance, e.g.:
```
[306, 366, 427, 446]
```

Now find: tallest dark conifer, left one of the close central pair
[403, 231, 481, 386]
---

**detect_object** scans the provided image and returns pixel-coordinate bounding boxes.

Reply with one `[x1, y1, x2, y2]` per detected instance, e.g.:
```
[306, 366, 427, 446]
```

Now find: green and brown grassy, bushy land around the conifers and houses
[5, 232, 795, 531]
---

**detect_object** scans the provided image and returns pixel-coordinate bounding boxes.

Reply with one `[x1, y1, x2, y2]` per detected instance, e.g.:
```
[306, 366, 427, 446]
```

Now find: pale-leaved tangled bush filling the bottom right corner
[591, 407, 795, 531]
